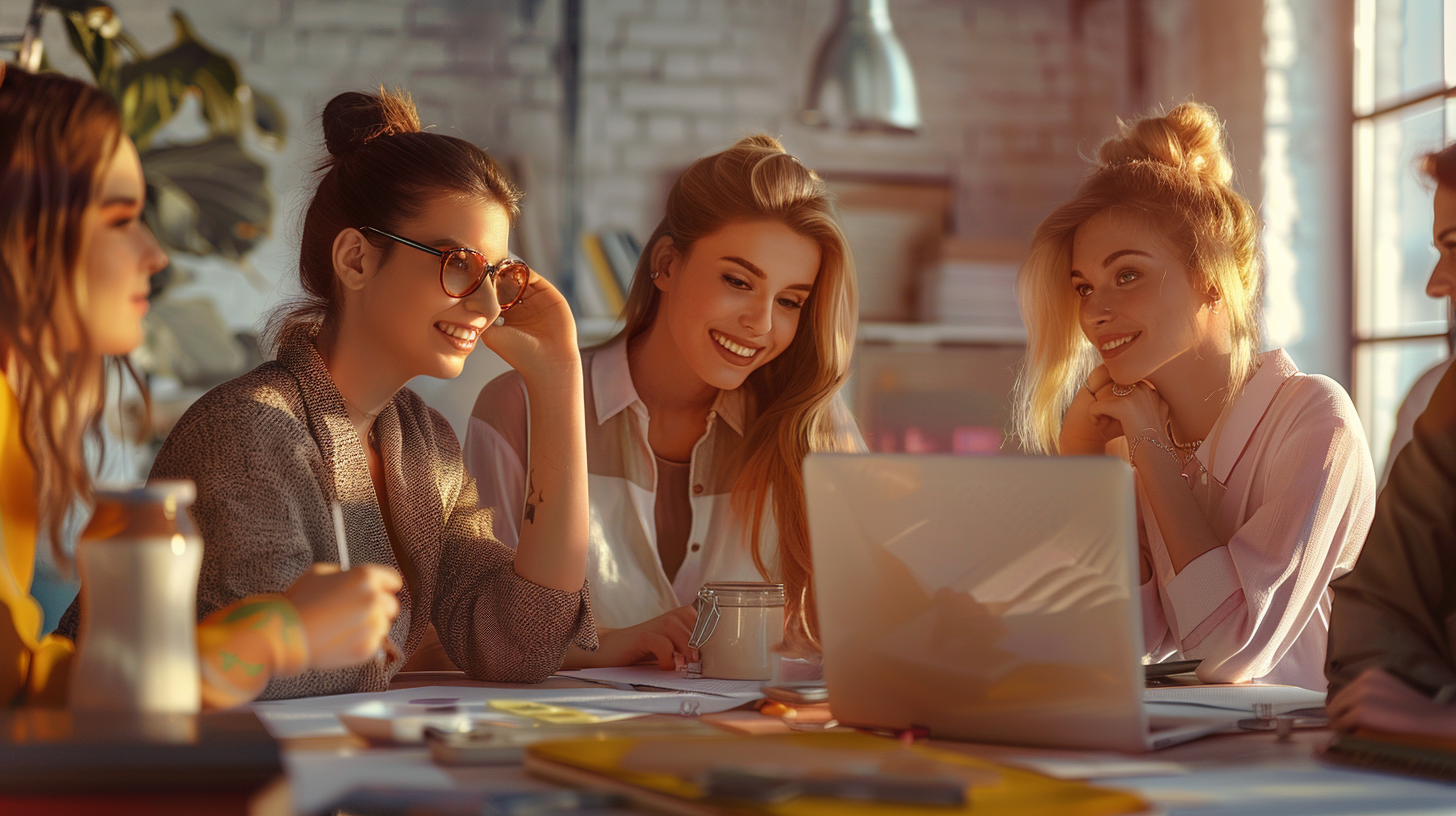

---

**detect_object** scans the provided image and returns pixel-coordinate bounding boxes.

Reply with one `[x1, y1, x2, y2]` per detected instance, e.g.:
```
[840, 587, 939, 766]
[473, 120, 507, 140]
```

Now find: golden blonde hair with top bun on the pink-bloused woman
[1013, 102, 1264, 453]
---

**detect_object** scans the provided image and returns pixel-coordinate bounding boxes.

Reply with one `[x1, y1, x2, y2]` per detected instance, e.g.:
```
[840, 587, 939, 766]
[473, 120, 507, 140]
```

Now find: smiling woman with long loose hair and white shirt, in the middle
[466, 136, 863, 667]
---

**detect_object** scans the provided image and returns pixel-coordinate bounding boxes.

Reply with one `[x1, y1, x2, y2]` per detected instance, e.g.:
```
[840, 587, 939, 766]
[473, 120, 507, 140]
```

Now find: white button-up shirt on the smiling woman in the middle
[464, 341, 863, 628]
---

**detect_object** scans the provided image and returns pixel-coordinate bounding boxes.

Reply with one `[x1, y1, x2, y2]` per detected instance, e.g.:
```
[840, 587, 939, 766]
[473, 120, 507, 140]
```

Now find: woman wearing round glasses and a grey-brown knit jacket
[55, 90, 596, 698]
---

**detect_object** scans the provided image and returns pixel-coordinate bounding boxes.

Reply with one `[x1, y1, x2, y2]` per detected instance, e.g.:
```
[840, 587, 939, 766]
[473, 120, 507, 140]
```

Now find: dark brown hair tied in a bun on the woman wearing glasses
[264, 87, 521, 348]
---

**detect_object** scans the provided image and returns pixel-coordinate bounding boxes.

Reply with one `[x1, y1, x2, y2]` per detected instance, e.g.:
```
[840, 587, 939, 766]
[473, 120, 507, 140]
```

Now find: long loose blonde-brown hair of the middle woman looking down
[609, 134, 858, 647]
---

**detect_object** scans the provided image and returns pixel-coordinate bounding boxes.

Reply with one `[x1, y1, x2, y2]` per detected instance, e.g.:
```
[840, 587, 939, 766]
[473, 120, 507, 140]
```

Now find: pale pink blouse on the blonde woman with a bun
[1139, 350, 1376, 691]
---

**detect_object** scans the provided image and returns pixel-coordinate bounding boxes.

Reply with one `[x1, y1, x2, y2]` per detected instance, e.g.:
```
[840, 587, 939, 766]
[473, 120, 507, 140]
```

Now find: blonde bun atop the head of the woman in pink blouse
[1098, 102, 1233, 185]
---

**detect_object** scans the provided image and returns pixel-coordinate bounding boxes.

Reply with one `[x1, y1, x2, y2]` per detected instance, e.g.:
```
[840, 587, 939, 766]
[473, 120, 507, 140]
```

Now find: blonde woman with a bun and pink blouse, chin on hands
[1015, 103, 1376, 689]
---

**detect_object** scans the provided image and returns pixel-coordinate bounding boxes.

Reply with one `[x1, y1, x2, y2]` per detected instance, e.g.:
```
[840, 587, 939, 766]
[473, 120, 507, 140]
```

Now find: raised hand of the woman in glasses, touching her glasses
[480, 270, 581, 383]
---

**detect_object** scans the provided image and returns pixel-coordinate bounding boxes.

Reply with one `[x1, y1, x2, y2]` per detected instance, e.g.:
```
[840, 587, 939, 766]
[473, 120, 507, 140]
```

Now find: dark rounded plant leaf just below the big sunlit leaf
[141, 136, 272, 259]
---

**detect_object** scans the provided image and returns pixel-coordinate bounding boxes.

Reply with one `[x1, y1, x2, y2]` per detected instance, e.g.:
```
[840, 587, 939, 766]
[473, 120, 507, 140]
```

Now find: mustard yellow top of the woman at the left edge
[0, 385, 309, 708]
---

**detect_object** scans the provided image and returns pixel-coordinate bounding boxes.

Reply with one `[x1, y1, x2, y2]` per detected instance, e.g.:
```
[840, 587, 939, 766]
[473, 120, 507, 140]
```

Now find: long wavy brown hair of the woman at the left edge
[0, 66, 146, 567]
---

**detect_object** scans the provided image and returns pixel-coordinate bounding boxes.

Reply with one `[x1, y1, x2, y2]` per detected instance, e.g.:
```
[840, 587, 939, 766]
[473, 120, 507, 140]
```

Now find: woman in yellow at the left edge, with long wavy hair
[0, 63, 399, 707]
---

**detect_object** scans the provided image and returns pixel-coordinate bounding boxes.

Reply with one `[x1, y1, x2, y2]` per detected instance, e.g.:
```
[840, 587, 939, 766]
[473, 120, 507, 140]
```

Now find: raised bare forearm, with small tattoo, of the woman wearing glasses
[515, 363, 590, 592]
